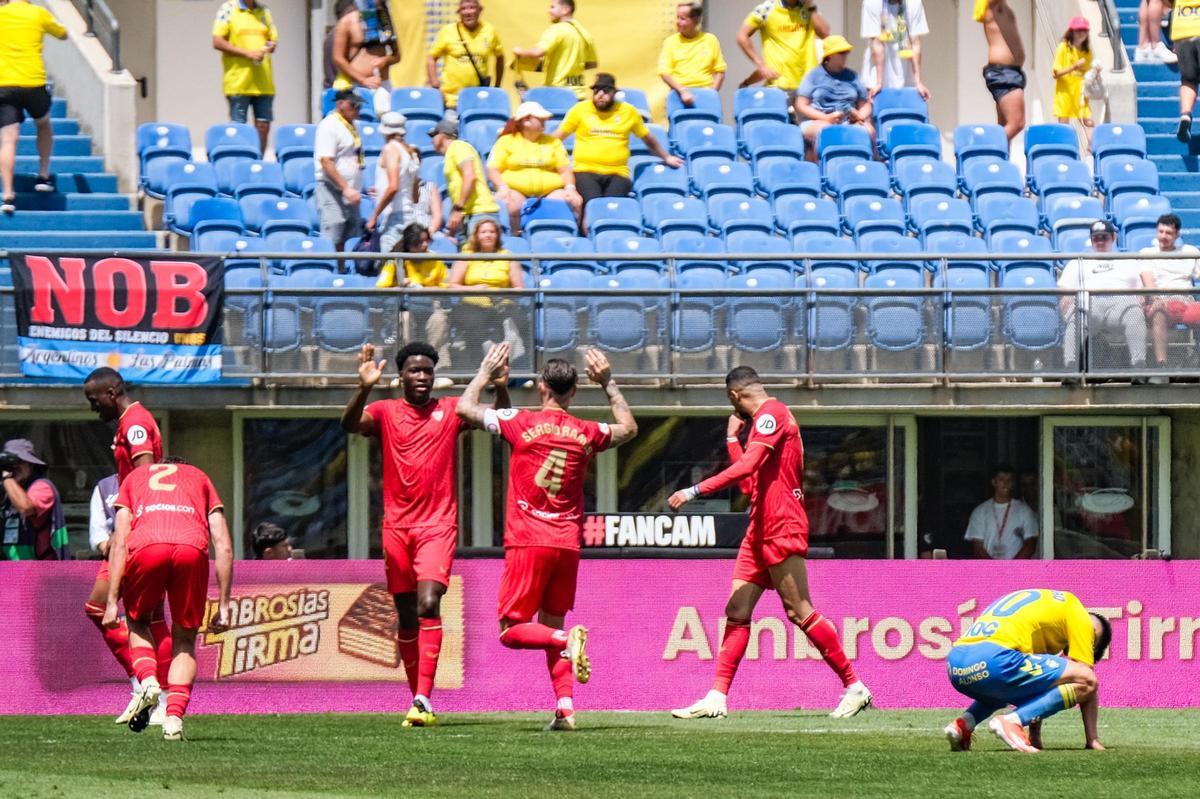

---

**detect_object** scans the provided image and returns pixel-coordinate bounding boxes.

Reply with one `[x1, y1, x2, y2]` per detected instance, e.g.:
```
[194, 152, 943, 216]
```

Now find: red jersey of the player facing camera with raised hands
[366, 397, 470, 528]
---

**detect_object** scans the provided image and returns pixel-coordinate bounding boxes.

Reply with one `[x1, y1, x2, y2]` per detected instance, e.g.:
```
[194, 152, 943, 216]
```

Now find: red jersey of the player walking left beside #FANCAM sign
[700, 400, 809, 537]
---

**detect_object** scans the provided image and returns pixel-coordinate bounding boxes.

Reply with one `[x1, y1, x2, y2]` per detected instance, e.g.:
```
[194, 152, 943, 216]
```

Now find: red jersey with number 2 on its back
[114, 463, 223, 552]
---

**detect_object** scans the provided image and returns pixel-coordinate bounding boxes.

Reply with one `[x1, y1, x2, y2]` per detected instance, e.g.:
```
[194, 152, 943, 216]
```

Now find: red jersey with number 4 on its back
[485, 408, 612, 549]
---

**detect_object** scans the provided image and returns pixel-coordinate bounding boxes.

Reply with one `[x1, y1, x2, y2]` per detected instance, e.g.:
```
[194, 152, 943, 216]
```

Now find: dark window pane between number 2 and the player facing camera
[242, 417, 349, 558]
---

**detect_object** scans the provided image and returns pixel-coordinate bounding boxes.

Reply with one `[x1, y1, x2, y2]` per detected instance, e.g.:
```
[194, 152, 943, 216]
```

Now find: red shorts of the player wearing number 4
[499, 547, 580, 621]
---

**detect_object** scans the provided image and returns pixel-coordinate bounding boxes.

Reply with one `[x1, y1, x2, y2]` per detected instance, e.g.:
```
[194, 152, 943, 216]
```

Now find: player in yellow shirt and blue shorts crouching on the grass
[946, 588, 1112, 752]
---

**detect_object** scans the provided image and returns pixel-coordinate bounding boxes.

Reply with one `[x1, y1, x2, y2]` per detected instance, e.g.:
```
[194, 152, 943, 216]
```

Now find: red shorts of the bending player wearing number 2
[121, 543, 209, 630]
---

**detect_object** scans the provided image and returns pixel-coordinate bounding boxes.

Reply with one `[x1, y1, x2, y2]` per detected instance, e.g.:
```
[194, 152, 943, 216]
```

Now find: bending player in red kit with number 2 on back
[103, 458, 233, 740]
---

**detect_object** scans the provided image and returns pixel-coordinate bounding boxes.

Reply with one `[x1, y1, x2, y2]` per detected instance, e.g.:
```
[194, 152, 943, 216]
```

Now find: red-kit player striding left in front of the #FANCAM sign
[667, 366, 871, 719]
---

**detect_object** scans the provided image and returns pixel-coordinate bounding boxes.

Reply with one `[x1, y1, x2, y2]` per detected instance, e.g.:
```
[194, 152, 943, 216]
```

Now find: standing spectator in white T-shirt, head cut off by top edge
[859, 0, 929, 100]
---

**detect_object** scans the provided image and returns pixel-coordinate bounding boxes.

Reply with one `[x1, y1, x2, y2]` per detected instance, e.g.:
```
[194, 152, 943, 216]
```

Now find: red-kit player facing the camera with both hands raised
[342, 342, 509, 727]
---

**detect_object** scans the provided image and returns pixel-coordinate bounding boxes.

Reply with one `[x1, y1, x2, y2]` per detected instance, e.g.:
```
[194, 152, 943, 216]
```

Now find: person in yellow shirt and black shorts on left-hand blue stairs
[0, 0, 67, 214]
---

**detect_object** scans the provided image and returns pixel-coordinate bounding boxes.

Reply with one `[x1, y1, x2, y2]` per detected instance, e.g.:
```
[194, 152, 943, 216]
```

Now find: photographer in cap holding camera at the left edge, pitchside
[0, 438, 71, 560]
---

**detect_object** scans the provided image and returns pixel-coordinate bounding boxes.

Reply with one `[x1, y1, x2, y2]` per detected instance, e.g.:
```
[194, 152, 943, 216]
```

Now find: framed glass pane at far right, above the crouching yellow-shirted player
[1043, 416, 1170, 559]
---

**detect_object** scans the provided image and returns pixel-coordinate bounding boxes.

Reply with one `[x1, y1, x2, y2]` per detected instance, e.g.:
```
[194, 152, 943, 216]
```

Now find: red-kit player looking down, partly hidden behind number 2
[83, 366, 170, 725]
